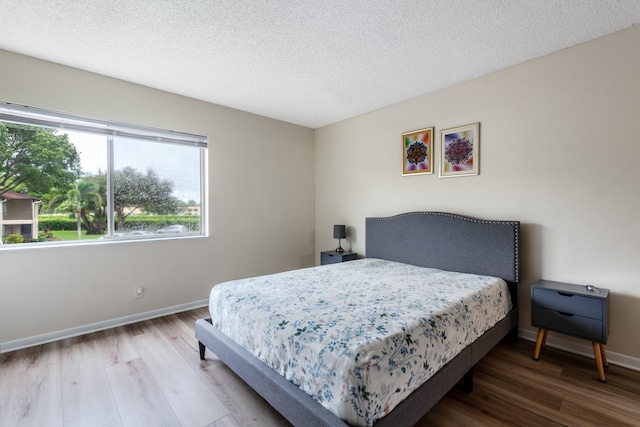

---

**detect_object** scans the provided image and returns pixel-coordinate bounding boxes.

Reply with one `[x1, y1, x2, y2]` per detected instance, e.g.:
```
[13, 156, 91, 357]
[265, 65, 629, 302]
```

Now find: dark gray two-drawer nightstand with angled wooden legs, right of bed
[531, 280, 609, 381]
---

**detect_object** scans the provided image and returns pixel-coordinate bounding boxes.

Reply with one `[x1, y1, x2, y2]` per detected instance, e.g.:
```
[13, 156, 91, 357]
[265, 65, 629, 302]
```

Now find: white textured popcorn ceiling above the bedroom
[0, 0, 640, 128]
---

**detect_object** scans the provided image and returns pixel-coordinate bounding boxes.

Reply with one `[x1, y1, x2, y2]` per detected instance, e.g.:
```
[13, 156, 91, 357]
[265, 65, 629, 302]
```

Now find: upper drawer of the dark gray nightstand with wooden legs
[533, 288, 604, 321]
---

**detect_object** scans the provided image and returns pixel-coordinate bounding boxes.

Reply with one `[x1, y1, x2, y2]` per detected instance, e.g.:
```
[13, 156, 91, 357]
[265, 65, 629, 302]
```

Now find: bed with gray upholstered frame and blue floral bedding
[196, 212, 520, 426]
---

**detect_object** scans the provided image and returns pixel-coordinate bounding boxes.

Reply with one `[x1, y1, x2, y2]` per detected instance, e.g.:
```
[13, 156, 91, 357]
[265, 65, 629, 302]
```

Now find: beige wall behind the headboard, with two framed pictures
[316, 26, 640, 366]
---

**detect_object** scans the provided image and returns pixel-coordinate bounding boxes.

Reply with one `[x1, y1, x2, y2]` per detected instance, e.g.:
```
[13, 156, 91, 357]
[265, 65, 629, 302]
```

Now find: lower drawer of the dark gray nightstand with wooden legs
[531, 307, 606, 342]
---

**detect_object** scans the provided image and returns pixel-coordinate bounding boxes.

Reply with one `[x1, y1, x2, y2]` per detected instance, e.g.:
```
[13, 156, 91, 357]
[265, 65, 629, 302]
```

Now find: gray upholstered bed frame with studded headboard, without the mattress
[196, 212, 520, 427]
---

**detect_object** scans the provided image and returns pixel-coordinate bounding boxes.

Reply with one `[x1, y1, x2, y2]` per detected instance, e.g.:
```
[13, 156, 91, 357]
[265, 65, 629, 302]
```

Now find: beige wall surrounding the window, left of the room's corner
[0, 51, 315, 343]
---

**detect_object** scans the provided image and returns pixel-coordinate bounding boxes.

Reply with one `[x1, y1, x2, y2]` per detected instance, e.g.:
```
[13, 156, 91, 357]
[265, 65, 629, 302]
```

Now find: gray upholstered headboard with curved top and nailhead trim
[366, 212, 520, 283]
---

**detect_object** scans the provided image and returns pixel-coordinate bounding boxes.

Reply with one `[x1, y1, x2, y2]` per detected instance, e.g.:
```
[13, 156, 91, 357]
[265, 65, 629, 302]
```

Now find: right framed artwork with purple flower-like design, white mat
[440, 123, 480, 178]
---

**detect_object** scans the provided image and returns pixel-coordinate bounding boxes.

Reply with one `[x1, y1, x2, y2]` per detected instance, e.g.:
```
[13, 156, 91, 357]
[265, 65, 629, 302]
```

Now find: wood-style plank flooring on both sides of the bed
[0, 308, 640, 427]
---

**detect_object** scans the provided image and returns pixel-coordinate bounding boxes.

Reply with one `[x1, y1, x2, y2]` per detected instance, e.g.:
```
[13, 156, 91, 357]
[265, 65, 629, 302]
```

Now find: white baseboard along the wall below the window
[0, 300, 209, 354]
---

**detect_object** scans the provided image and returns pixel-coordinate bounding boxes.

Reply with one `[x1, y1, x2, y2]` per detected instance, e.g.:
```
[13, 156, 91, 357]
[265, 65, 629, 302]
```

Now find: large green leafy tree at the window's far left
[0, 122, 80, 196]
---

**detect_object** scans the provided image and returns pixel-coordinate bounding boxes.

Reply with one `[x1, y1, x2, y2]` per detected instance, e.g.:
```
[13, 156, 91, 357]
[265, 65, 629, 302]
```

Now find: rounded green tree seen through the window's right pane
[113, 167, 182, 228]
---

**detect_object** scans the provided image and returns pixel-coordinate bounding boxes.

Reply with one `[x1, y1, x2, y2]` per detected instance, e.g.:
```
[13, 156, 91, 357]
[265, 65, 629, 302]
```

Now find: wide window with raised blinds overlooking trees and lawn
[0, 103, 207, 248]
